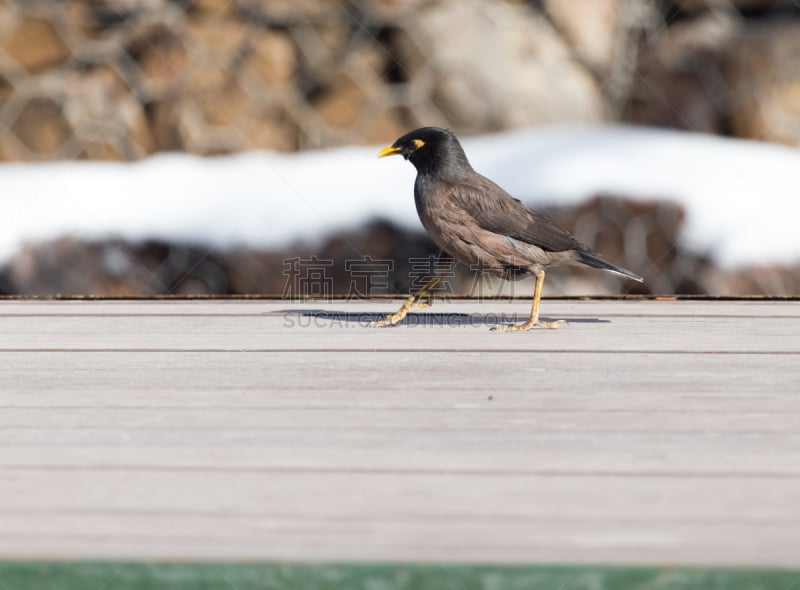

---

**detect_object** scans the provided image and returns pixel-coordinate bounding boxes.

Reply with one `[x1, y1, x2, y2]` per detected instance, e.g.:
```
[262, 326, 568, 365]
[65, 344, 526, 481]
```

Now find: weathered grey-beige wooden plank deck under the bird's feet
[0, 301, 800, 572]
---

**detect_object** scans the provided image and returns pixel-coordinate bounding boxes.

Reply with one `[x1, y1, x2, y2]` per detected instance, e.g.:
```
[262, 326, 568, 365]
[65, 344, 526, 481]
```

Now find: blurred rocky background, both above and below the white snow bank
[0, 0, 800, 295]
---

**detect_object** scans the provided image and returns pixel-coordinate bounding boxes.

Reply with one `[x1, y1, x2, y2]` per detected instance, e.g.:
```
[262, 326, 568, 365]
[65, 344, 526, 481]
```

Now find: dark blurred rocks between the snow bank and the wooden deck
[0, 200, 800, 296]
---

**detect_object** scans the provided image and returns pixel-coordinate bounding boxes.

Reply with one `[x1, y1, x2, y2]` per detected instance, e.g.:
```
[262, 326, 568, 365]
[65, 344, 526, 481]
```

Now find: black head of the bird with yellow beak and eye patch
[378, 127, 472, 178]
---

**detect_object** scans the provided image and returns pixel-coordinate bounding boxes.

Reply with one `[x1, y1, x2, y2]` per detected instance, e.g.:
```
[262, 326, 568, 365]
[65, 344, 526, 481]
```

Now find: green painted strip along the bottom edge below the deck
[0, 562, 800, 590]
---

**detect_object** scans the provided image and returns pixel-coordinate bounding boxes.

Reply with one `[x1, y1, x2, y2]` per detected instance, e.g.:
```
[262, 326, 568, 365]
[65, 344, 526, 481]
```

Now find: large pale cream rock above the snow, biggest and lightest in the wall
[408, 1, 604, 131]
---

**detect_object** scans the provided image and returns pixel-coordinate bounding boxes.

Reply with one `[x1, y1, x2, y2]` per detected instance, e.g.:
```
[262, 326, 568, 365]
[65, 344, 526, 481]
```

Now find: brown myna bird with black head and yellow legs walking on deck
[370, 127, 642, 332]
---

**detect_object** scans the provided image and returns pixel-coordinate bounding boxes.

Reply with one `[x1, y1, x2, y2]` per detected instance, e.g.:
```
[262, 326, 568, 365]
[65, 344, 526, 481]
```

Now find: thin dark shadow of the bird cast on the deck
[276, 309, 611, 327]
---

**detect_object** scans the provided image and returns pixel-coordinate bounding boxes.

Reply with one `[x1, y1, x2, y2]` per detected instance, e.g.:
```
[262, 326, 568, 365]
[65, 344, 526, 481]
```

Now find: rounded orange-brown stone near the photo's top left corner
[0, 17, 70, 72]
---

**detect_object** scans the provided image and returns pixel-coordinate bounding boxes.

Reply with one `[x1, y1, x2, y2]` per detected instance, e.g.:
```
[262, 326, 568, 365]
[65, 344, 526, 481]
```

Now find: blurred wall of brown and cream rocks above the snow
[0, 0, 800, 159]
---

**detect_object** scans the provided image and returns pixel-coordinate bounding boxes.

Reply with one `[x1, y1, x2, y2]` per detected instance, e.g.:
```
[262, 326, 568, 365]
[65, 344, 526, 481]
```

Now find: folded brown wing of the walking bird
[450, 173, 589, 252]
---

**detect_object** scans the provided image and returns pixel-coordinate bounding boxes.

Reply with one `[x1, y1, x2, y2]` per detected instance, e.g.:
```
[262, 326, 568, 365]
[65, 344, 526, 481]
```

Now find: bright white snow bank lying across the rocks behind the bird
[0, 127, 800, 267]
